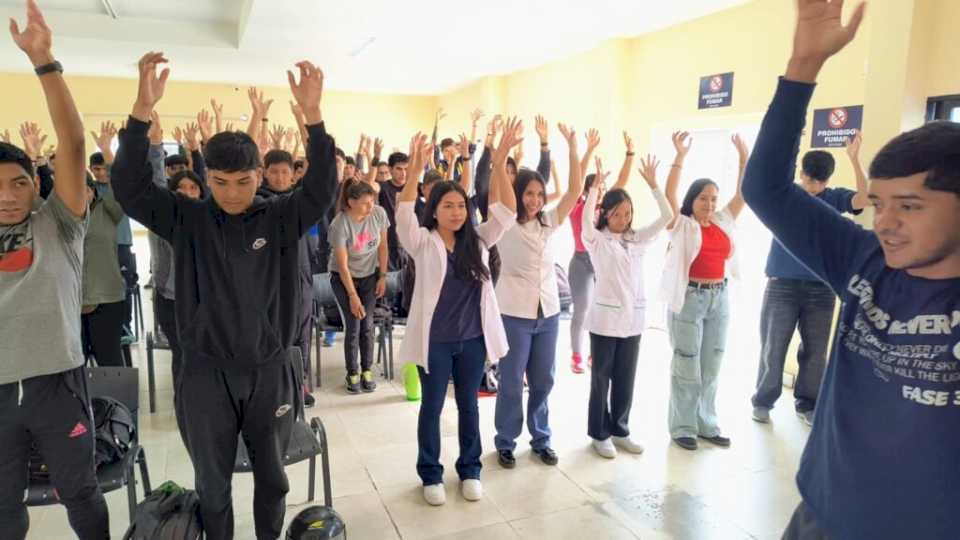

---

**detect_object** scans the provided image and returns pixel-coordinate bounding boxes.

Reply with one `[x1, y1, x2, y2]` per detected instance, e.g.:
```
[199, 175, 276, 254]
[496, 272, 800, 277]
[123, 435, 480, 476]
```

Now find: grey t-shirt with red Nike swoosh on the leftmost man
[0, 192, 87, 384]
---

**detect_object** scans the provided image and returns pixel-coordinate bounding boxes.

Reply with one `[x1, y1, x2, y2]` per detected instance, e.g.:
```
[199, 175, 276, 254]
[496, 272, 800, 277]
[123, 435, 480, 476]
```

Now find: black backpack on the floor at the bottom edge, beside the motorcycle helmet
[123, 482, 203, 540]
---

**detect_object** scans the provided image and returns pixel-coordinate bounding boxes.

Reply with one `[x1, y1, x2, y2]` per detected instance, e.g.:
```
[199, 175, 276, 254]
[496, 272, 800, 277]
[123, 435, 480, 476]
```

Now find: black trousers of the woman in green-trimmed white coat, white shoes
[587, 332, 640, 441]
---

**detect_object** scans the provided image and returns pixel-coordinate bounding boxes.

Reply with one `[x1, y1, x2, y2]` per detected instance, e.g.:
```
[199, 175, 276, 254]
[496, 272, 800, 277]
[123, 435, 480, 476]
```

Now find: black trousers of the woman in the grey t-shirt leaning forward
[330, 272, 377, 375]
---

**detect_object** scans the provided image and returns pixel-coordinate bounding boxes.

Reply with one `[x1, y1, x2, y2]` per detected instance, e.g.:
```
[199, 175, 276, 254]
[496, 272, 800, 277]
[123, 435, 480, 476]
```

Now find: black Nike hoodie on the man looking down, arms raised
[111, 117, 337, 372]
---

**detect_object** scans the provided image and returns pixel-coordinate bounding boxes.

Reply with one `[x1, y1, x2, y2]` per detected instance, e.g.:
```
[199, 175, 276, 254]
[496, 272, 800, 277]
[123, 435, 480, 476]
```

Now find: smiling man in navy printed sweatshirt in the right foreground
[743, 0, 960, 540]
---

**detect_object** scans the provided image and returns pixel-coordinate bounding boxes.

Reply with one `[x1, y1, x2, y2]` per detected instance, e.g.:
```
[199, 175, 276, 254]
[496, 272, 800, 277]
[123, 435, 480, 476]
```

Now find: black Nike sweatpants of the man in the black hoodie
[175, 354, 302, 540]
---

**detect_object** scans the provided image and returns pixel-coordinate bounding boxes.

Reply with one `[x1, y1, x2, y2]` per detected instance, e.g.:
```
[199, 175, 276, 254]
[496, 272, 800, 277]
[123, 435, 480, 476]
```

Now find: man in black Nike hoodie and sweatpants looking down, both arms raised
[112, 53, 336, 540]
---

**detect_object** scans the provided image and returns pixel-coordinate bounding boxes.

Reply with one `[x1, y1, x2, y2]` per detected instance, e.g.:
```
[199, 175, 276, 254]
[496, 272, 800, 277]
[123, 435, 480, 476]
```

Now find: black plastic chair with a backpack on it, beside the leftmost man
[25, 367, 150, 521]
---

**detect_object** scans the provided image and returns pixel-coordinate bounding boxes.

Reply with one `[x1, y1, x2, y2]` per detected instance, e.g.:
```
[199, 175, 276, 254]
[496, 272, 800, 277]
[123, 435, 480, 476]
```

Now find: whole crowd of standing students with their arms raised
[0, 0, 960, 539]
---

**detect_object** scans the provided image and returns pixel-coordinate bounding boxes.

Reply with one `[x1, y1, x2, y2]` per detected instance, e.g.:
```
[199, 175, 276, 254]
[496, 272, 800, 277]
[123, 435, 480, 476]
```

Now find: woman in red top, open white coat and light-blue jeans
[664, 133, 749, 450]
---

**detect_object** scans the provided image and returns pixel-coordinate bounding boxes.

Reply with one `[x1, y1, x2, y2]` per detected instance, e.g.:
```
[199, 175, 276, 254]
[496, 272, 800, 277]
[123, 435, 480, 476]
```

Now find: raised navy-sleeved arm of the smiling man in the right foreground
[743, 0, 876, 291]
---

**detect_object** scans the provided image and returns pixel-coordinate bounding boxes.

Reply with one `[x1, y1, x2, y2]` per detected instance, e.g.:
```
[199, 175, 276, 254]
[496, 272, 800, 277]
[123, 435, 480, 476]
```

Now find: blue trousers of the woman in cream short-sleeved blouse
[494, 314, 560, 450]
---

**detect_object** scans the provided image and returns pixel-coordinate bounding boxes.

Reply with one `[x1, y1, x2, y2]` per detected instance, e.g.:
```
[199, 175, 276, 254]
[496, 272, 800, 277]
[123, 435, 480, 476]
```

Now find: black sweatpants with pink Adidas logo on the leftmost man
[0, 368, 110, 540]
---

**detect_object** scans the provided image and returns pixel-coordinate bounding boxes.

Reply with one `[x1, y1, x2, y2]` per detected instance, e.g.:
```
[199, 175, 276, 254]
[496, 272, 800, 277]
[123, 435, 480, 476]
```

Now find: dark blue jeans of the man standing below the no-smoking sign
[752, 278, 836, 412]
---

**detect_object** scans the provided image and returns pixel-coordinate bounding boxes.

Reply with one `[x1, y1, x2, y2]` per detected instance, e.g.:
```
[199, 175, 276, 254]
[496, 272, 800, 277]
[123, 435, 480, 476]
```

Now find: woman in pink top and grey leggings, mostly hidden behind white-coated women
[567, 129, 634, 373]
